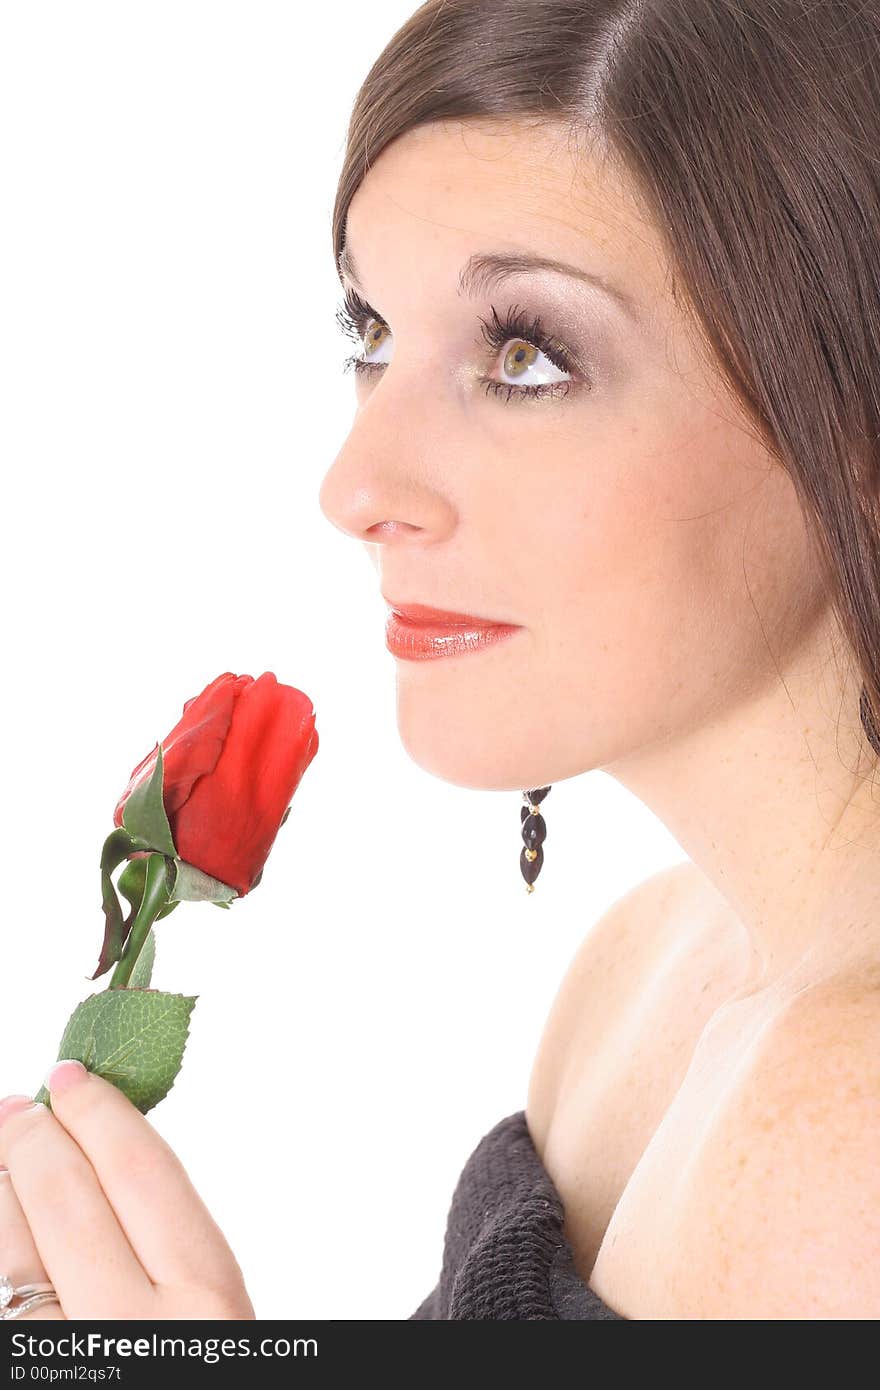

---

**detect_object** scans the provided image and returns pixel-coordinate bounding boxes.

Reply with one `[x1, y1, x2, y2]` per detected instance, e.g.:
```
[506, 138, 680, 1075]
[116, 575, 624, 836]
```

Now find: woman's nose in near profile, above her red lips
[318, 396, 456, 545]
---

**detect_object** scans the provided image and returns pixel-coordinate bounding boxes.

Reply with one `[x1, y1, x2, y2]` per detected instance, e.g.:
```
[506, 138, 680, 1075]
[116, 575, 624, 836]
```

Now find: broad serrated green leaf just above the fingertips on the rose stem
[35, 988, 199, 1115]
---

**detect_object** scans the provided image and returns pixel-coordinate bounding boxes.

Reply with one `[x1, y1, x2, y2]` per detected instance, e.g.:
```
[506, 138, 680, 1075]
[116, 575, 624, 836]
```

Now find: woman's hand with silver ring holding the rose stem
[0, 1062, 256, 1322]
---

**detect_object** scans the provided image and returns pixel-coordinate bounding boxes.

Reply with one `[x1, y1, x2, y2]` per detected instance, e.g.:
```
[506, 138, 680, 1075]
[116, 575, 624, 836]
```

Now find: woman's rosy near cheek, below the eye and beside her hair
[530, 407, 812, 760]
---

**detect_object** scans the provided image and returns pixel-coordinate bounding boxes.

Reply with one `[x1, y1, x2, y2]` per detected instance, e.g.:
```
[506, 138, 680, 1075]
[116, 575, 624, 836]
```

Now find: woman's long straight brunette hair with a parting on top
[332, 0, 880, 752]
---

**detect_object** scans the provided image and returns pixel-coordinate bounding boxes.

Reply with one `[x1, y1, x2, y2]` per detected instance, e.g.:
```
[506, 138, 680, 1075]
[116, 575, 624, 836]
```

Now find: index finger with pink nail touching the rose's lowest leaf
[46, 1062, 239, 1291]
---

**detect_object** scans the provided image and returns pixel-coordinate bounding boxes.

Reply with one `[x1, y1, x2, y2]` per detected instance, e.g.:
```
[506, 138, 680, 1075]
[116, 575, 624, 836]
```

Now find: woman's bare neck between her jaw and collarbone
[602, 614, 880, 992]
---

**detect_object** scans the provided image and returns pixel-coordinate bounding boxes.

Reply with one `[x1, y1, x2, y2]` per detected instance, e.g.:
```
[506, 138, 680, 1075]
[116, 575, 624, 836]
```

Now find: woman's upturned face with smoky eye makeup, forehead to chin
[320, 120, 823, 790]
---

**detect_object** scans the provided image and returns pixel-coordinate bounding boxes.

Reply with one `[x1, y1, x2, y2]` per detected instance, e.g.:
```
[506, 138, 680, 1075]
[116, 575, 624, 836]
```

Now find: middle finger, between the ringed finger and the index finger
[0, 1105, 154, 1318]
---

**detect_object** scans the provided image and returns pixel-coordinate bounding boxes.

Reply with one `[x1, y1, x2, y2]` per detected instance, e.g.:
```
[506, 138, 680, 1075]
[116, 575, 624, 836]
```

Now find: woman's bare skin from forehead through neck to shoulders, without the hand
[320, 120, 880, 1318]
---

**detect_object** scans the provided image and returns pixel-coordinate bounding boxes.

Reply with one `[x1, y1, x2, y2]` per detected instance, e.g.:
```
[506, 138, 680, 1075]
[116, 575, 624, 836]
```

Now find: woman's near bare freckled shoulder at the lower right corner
[670, 970, 880, 1321]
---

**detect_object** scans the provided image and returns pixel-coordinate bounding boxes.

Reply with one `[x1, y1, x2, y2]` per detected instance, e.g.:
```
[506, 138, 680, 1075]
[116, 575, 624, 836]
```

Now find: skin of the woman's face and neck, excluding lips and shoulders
[320, 121, 880, 980]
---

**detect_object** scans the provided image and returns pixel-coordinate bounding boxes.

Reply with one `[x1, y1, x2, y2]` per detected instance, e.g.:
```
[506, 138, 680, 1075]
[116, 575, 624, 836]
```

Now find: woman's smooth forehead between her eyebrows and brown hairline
[339, 118, 667, 313]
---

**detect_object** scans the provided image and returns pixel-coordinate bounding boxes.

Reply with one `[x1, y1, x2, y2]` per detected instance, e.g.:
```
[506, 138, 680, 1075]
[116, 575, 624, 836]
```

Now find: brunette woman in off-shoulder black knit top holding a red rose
[0, 0, 880, 1319]
